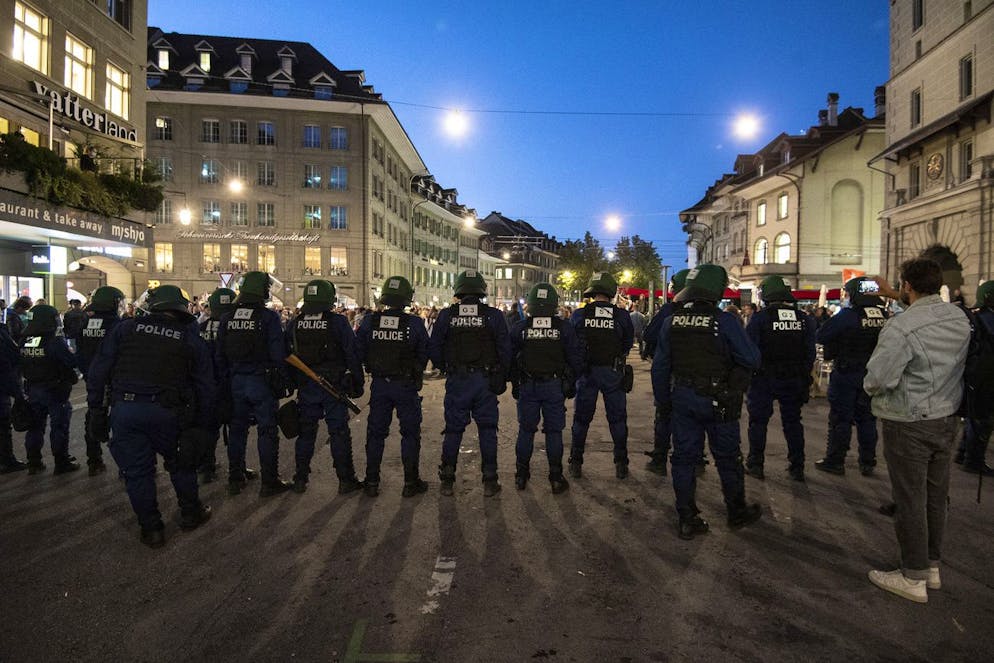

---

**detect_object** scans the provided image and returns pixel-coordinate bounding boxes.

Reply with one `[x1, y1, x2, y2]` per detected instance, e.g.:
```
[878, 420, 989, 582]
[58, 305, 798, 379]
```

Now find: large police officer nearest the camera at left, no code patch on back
[86, 285, 215, 548]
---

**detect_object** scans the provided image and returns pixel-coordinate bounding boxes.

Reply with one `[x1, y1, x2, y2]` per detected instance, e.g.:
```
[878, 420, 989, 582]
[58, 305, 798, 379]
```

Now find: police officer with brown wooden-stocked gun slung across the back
[286, 279, 363, 495]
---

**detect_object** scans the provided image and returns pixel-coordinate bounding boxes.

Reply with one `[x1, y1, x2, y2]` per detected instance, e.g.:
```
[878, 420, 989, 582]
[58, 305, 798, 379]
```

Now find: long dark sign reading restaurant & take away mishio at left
[0, 190, 152, 247]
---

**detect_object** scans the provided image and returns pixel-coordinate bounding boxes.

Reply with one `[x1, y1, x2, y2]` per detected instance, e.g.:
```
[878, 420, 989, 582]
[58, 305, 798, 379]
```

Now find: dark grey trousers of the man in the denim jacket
[882, 417, 960, 580]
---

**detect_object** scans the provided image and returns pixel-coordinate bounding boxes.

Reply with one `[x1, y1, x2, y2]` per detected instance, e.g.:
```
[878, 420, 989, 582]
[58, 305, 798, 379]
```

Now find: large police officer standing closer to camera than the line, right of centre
[652, 265, 762, 539]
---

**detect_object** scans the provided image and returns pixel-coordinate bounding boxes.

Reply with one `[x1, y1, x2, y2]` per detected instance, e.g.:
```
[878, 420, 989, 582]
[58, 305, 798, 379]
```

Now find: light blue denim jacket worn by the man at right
[863, 295, 970, 421]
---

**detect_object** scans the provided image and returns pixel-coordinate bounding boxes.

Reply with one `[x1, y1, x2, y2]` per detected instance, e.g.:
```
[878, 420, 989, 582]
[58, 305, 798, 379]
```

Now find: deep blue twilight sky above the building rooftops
[149, 0, 888, 268]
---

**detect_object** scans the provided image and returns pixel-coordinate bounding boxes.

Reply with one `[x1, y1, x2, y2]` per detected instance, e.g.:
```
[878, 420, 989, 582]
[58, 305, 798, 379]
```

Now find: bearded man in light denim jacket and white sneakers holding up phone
[863, 258, 970, 603]
